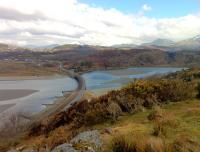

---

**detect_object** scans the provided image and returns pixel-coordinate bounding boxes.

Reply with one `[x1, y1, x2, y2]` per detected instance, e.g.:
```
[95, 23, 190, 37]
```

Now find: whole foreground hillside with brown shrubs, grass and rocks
[0, 69, 200, 152]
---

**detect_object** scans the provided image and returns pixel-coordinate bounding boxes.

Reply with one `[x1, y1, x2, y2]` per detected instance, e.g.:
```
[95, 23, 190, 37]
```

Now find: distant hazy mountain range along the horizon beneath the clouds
[0, 35, 200, 52]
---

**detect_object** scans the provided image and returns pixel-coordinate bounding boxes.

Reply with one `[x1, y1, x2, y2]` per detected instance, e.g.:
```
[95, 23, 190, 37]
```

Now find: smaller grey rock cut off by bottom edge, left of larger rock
[51, 143, 79, 152]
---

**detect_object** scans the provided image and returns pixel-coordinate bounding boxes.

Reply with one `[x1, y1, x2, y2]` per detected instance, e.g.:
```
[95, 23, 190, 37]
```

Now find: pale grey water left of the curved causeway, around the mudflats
[0, 77, 77, 113]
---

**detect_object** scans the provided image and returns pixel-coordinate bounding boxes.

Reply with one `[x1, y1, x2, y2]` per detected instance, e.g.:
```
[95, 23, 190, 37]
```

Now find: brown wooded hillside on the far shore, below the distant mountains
[0, 46, 200, 75]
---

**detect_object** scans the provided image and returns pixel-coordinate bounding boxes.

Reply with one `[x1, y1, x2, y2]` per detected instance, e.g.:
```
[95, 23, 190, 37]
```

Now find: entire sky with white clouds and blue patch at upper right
[0, 0, 200, 46]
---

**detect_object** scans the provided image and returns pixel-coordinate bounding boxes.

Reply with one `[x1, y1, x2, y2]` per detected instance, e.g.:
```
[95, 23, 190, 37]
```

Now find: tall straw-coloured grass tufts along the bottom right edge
[110, 134, 200, 152]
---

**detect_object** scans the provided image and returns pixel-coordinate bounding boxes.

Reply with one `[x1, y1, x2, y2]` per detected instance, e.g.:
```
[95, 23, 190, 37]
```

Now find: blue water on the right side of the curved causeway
[83, 67, 182, 94]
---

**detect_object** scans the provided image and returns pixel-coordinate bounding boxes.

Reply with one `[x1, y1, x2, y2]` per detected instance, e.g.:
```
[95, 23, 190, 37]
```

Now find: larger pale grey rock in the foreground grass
[70, 130, 102, 152]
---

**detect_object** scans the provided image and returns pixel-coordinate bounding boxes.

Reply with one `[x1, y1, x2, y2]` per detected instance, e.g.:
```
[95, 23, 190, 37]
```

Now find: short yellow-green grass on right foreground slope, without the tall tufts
[93, 99, 200, 151]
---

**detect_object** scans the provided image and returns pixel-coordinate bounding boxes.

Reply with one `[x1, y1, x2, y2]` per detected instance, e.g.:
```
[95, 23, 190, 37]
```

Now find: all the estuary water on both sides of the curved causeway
[0, 68, 182, 113]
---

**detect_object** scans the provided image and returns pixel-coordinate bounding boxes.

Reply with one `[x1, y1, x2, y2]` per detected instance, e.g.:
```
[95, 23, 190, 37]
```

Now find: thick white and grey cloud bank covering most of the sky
[0, 0, 200, 45]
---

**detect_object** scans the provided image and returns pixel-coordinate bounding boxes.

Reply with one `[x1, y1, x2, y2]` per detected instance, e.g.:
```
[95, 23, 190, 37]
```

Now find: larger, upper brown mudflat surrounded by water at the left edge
[0, 89, 38, 101]
